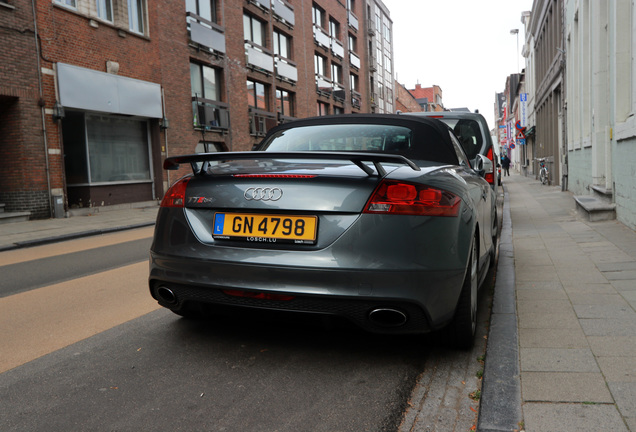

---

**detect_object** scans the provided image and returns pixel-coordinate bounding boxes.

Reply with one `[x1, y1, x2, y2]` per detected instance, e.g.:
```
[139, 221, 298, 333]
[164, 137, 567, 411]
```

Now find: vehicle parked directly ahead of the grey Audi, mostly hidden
[404, 111, 501, 196]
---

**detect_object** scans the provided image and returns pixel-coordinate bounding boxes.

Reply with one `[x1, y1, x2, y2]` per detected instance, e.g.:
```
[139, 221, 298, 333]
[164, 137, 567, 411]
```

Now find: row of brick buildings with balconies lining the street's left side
[0, 0, 394, 218]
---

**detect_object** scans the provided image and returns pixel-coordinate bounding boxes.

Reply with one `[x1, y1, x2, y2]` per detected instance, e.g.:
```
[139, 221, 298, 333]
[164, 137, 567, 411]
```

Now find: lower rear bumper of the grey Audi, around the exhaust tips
[149, 253, 464, 333]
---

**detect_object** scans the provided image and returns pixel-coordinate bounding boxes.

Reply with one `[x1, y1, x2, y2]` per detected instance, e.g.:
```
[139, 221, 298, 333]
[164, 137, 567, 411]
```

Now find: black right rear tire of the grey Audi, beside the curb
[445, 238, 478, 350]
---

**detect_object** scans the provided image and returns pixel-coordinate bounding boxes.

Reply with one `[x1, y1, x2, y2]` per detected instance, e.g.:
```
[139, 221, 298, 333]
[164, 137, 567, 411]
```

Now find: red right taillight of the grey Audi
[364, 180, 461, 217]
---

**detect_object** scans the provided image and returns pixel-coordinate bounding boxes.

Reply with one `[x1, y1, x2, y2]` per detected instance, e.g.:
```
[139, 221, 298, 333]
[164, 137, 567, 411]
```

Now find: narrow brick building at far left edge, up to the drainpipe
[0, 2, 50, 218]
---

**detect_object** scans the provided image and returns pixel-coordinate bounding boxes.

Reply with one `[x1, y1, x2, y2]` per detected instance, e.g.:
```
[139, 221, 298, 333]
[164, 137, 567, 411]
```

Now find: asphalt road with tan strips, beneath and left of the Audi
[0, 230, 492, 432]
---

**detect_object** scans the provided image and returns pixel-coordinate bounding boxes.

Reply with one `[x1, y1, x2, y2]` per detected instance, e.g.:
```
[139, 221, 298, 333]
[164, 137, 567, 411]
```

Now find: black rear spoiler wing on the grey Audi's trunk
[163, 151, 420, 177]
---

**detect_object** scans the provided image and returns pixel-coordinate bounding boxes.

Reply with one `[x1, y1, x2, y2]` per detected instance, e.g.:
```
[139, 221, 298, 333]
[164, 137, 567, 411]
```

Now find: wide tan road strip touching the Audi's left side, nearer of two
[0, 262, 159, 373]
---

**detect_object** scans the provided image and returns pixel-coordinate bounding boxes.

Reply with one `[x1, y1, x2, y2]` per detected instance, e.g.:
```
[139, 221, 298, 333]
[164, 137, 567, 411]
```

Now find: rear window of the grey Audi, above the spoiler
[259, 124, 457, 164]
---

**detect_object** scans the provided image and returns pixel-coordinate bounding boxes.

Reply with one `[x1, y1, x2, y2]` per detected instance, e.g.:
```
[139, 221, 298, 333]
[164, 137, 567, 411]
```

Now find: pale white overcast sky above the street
[382, 0, 532, 129]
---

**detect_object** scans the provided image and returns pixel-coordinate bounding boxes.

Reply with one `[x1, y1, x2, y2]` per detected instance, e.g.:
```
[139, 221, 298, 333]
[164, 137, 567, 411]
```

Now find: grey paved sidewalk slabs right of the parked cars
[502, 175, 636, 432]
